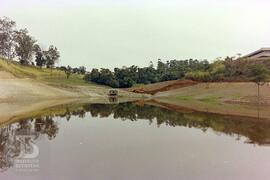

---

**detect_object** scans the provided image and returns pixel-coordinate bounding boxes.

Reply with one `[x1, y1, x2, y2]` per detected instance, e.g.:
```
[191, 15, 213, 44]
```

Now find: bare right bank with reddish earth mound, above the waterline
[127, 77, 270, 105]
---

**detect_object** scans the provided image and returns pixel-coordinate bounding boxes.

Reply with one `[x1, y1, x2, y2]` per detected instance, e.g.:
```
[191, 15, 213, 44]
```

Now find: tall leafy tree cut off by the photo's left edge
[0, 17, 16, 60]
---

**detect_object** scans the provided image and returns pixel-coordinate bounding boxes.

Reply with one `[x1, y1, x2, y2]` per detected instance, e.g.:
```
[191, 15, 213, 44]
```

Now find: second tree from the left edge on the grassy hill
[14, 29, 36, 65]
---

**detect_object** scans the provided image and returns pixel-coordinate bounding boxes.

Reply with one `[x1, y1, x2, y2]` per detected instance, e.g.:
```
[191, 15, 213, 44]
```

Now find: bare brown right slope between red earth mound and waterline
[155, 82, 270, 104]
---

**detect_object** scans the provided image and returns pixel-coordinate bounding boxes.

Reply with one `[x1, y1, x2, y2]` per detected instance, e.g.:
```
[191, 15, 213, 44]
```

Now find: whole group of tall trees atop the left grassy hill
[0, 17, 60, 68]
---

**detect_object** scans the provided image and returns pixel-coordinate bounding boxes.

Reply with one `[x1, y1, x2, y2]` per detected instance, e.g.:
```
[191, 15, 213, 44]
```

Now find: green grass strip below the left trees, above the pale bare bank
[0, 59, 93, 86]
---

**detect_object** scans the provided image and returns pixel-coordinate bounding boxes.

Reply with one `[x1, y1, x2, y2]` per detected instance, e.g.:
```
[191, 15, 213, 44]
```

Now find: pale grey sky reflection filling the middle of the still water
[0, 113, 270, 180]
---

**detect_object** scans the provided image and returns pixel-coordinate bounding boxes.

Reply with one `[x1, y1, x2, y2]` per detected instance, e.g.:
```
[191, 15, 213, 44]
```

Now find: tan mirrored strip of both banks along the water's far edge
[0, 93, 270, 126]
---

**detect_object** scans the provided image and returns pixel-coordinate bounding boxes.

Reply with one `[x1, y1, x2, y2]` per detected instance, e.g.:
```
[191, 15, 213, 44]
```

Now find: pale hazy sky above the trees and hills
[0, 0, 270, 69]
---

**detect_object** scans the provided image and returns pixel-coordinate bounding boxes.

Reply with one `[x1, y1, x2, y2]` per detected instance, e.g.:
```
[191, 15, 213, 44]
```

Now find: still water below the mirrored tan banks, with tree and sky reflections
[0, 103, 270, 180]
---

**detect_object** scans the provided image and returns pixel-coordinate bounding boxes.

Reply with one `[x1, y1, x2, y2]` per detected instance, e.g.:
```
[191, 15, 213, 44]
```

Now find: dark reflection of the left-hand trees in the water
[0, 116, 58, 171]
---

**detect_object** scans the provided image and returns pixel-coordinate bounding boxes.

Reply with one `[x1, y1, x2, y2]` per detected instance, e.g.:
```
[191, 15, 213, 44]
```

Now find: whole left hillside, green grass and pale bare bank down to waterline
[0, 59, 146, 101]
